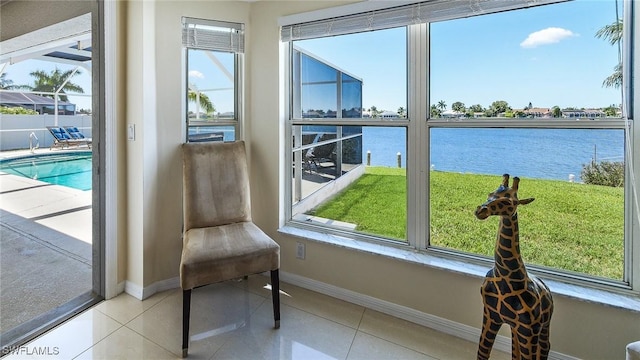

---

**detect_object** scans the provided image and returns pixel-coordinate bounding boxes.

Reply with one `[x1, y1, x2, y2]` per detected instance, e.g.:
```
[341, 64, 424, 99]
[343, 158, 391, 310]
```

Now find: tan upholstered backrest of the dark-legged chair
[182, 141, 251, 231]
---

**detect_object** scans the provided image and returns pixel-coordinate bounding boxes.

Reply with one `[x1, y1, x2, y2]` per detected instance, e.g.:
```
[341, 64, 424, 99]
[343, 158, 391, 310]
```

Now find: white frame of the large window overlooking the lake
[281, 1, 640, 296]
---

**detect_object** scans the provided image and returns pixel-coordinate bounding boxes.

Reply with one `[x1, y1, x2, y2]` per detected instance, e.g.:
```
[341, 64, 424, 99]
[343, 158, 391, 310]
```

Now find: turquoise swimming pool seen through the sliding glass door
[0, 151, 91, 190]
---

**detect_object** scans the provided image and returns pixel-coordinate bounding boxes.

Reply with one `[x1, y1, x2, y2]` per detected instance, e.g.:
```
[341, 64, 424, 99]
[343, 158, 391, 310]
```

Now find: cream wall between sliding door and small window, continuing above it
[123, 1, 249, 297]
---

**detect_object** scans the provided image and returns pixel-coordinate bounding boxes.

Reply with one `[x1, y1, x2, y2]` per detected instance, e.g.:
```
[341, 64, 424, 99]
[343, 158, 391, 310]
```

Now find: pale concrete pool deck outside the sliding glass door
[0, 149, 92, 332]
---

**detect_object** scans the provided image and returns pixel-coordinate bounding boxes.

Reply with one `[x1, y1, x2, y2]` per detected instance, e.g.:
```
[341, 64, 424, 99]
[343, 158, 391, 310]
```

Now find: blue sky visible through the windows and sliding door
[0, 0, 622, 112]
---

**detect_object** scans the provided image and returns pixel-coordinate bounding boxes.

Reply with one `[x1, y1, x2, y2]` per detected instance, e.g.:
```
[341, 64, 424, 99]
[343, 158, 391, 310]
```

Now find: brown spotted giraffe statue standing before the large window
[475, 174, 553, 360]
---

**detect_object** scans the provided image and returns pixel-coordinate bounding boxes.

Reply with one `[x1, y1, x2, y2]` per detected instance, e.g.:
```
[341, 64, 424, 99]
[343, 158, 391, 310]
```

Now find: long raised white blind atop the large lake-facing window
[280, 0, 570, 41]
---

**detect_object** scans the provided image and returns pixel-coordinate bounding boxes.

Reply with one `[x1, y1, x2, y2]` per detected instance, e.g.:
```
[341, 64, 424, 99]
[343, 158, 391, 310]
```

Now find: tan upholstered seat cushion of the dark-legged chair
[180, 222, 280, 290]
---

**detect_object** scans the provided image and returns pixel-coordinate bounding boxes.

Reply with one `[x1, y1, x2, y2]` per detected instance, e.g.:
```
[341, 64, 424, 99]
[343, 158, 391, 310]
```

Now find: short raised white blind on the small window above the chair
[182, 17, 244, 53]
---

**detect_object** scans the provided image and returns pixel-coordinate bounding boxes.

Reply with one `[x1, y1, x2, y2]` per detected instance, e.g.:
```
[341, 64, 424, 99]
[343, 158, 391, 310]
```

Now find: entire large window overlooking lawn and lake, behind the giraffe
[282, 0, 640, 290]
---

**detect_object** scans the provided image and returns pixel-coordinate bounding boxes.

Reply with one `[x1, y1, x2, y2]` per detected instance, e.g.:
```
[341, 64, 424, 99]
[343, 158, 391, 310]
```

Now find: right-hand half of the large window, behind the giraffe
[426, 1, 625, 282]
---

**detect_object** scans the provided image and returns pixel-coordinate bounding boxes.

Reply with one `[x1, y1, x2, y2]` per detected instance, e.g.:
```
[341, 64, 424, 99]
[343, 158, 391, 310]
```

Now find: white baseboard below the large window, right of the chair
[280, 271, 579, 360]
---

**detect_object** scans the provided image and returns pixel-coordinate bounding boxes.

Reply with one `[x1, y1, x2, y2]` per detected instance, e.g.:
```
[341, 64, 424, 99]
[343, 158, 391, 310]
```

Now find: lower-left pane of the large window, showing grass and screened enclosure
[292, 126, 406, 241]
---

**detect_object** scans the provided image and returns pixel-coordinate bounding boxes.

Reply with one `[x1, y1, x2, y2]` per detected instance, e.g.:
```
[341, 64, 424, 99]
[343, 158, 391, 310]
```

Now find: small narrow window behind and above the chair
[183, 18, 244, 142]
